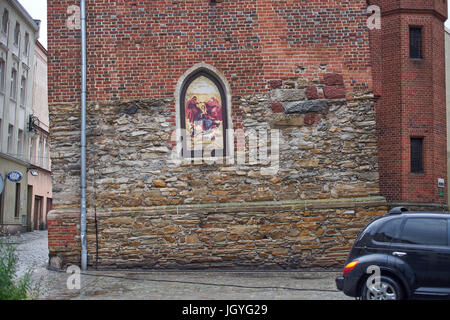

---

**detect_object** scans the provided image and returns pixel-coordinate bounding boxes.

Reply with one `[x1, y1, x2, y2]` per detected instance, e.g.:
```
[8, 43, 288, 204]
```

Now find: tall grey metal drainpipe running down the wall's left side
[80, 0, 87, 270]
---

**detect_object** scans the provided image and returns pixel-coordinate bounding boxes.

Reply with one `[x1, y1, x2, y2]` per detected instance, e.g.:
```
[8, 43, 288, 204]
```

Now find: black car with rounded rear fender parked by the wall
[336, 207, 450, 300]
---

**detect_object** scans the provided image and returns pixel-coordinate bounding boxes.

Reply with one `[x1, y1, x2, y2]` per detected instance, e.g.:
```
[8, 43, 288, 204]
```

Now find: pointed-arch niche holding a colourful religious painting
[180, 71, 228, 158]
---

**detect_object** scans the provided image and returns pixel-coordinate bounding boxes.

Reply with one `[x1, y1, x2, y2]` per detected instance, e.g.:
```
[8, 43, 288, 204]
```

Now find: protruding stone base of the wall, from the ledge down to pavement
[48, 197, 387, 270]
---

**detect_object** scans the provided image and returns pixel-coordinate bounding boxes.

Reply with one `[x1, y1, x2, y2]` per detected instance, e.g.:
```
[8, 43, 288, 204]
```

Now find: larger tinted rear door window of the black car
[400, 218, 448, 246]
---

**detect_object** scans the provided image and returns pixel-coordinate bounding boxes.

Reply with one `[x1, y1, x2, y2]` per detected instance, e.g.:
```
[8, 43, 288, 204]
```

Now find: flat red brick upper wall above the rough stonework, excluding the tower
[48, 0, 372, 103]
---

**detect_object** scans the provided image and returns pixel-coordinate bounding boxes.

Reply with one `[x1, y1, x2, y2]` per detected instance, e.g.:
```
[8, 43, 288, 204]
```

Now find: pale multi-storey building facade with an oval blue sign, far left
[0, 0, 39, 232]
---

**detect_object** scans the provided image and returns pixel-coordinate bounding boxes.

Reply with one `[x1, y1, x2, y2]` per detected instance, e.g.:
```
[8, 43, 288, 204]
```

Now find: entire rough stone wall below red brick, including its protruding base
[49, 74, 386, 268]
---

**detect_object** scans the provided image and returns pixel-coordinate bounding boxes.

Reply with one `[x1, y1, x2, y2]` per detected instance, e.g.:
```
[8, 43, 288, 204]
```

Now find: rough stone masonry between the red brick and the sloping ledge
[51, 79, 379, 209]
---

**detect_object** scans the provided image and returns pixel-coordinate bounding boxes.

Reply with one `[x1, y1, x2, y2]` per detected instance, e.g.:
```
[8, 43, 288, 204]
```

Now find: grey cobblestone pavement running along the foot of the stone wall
[5, 231, 350, 300]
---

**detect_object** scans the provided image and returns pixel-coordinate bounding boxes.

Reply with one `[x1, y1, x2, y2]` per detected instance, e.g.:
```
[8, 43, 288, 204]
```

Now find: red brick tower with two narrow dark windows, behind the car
[368, 0, 448, 209]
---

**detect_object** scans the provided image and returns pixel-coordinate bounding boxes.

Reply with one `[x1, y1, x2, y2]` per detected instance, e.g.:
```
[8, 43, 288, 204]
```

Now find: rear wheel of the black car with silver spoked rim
[361, 276, 403, 300]
